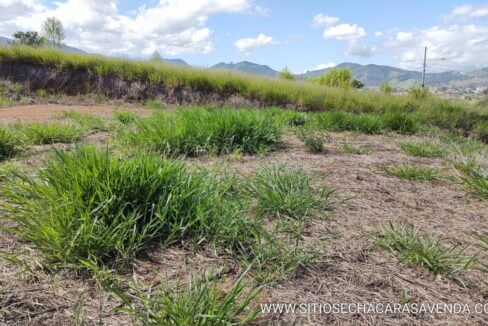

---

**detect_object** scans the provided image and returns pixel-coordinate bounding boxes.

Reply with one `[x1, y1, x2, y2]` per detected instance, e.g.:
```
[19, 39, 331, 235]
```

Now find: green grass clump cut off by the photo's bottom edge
[113, 275, 260, 326]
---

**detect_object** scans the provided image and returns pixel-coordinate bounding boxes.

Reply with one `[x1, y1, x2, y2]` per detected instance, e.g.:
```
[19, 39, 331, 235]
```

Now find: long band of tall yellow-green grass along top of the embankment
[0, 47, 488, 138]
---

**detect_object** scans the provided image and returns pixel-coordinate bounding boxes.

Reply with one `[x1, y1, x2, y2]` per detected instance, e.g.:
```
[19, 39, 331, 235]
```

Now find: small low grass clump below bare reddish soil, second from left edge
[18, 123, 84, 145]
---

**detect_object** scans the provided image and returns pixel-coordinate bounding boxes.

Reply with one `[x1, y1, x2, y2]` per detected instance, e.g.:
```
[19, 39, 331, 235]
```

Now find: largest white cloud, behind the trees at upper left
[0, 0, 251, 56]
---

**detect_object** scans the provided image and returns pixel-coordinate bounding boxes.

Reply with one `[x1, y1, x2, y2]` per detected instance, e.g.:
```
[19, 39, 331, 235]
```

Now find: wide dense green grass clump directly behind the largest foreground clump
[123, 109, 281, 156]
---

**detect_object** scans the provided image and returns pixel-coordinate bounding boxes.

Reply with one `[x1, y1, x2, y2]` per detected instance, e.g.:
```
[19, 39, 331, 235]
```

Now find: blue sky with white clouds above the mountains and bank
[0, 0, 488, 73]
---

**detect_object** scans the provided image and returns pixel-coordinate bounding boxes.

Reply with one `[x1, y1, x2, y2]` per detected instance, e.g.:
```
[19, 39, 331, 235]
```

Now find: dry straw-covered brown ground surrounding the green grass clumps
[0, 108, 488, 325]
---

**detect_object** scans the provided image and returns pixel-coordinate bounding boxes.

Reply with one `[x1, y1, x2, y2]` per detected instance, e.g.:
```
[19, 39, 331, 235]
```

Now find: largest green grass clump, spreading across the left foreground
[3, 147, 255, 268]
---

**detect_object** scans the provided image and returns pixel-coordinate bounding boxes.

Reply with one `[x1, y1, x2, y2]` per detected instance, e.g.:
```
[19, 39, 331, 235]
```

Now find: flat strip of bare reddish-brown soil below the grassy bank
[0, 104, 153, 123]
